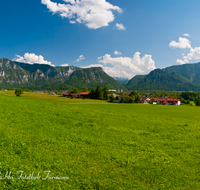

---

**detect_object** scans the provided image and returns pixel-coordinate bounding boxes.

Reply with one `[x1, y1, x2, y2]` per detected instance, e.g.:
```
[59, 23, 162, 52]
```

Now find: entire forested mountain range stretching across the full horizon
[0, 58, 200, 91]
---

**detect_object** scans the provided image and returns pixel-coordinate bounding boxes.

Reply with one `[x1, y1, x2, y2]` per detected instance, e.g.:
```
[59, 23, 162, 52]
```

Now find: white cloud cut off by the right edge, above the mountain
[176, 47, 200, 64]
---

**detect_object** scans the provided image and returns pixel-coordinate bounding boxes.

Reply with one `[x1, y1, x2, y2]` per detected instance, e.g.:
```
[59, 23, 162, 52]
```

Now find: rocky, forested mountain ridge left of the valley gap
[0, 58, 125, 89]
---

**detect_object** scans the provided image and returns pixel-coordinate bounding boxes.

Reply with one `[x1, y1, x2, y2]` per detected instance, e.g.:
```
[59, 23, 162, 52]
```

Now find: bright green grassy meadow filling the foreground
[0, 94, 200, 190]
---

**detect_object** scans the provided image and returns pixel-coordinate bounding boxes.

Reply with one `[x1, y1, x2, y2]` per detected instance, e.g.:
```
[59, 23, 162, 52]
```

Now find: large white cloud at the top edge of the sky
[41, 0, 123, 29]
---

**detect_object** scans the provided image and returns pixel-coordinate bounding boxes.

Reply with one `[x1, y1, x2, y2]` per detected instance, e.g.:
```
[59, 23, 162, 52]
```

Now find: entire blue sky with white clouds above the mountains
[0, 0, 200, 78]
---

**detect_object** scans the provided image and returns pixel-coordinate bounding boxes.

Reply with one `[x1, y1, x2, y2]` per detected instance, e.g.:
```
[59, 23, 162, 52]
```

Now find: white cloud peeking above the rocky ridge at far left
[13, 53, 52, 66]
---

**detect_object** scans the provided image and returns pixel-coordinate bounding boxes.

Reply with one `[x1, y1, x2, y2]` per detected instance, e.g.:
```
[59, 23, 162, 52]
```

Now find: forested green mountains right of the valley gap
[125, 63, 200, 91]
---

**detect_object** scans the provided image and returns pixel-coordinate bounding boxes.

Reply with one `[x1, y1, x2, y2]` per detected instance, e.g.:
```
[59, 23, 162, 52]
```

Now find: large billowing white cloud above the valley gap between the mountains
[84, 52, 156, 79]
